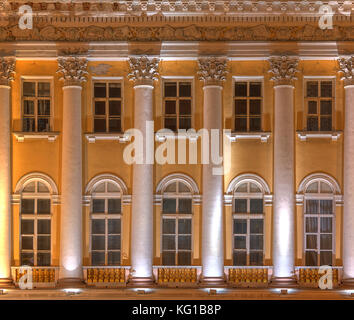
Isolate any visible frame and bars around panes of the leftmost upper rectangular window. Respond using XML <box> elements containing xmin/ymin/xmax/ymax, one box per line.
<box><xmin>20</xmin><ymin>76</ymin><xmax>55</xmax><ymax>135</ymax></box>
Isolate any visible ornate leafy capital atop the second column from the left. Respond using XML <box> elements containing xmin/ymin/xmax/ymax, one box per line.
<box><xmin>57</xmin><ymin>55</ymin><xmax>88</xmax><ymax>87</ymax></box>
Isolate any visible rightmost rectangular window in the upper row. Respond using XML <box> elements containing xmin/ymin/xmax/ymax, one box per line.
<box><xmin>305</xmin><ymin>80</ymin><xmax>334</xmax><ymax>131</ymax></box>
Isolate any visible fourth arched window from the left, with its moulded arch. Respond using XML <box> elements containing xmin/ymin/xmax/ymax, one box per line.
<box><xmin>227</xmin><ymin>174</ymin><xmax>270</xmax><ymax>266</ymax></box>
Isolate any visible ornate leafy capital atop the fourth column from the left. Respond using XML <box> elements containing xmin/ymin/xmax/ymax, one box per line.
<box><xmin>198</xmin><ymin>57</ymin><xmax>227</xmax><ymax>86</ymax></box>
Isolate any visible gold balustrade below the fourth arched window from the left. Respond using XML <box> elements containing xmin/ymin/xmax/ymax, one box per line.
<box><xmin>225</xmin><ymin>266</ymin><xmax>272</xmax><ymax>288</ymax></box>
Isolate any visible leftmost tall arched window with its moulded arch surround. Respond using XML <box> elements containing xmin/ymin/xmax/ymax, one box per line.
<box><xmin>15</xmin><ymin>173</ymin><xmax>58</xmax><ymax>266</ymax></box>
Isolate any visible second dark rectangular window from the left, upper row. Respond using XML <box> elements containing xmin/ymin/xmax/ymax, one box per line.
<box><xmin>93</xmin><ymin>82</ymin><xmax>122</xmax><ymax>133</ymax></box>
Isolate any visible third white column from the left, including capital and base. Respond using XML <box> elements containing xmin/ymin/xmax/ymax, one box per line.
<box><xmin>129</xmin><ymin>57</ymin><xmax>158</xmax><ymax>286</ymax></box>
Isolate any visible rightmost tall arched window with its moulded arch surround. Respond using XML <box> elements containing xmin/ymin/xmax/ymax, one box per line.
<box><xmin>299</xmin><ymin>174</ymin><xmax>340</xmax><ymax>266</ymax></box>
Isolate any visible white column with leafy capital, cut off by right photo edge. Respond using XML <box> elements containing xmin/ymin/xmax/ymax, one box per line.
<box><xmin>339</xmin><ymin>56</ymin><xmax>354</xmax><ymax>287</ymax></box>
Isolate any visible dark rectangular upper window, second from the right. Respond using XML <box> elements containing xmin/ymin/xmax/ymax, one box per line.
<box><xmin>234</xmin><ymin>81</ymin><xmax>262</xmax><ymax>132</ymax></box>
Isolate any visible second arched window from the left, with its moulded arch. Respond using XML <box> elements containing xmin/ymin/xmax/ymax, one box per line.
<box><xmin>86</xmin><ymin>175</ymin><xmax>127</xmax><ymax>266</ymax></box>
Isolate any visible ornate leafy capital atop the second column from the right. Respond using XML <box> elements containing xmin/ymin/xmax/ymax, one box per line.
<box><xmin>268</xmin><ymin>55</ymin><xmax>299</xmax><ymax>86</ymax></box>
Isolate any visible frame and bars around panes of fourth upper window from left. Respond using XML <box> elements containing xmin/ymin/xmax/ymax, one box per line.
<box><xmin>232</xmin><ymin>76</ymin><xmax>265</xmax><ymax>133</ymax></box>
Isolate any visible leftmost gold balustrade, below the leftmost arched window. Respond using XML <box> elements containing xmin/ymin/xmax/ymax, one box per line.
<box><xmin>11</xmin><ymin>267</ymin><xmax>59</xmax><ymax>288</ymax></box>
